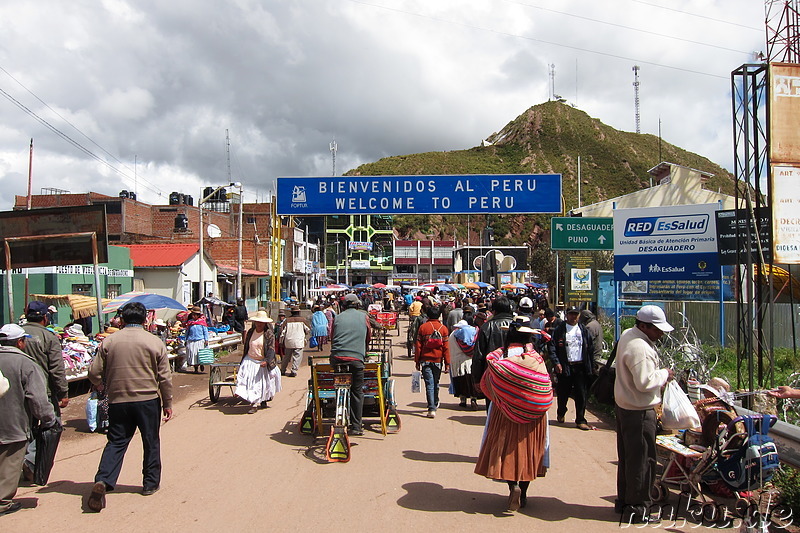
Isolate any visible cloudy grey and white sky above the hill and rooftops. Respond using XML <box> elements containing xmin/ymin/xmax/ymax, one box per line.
<box><xmin>0</xmin><ymin>0</ymin><xmax>765</xmax><ymax>210</ymax></box>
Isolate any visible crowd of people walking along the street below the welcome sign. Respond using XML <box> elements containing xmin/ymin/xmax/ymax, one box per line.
<box><xmin>0</xmin><ymin>291</ymin><xmax>800</xmax><ymax>523</ymax></box>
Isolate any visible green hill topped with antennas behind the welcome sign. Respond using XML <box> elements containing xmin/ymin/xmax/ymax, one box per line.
<box><xmin>346</xmin><ymin>102</ymin><xmax>734</xmax><ymax>246</ymax></box>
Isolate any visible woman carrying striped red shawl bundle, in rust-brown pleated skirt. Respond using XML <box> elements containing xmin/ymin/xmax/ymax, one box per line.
<box><xmin>475</xmin><ymin>316</ymin><xmax>553</xmax><ymax>511</ymax></box>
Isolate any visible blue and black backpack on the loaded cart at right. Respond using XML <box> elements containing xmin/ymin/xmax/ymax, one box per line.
<box><xmin>717</xmin><ymin>415</ymin><xmax>780</xmax><ymax>491</ymax></box>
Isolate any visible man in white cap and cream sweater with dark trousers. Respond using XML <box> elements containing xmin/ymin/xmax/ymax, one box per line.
<box><xmin>614</xmin><ymin>305</ymin><xmax>674</xmax><ymax>523</ymax></box>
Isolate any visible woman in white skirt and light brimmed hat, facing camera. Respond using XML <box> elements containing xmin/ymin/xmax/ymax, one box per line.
<box><xmin>234</xmin><ymin>311</ymin><xmax>281</xmax><ymax>414</ymax></box>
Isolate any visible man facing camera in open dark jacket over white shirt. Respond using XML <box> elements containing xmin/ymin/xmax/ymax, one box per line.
<box><xmin>550</xmin><ymin>307</ymin><xmax>594</xmax><ymax>431</ymax></box>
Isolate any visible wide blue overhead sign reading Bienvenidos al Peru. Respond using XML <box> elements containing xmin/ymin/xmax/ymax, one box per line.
<box><xmin>277</xmin><ymin>174</ymin><xmax>561</xmax><ymax>215</ymax></box>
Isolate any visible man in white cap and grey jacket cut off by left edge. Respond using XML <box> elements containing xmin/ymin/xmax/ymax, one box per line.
<box><xmin>0</xmin><ymin>324</ymin><xmax>57</xmax><ymax>515</ymax></box>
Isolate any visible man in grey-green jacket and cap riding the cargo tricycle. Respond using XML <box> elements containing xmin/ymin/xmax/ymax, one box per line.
<box><xmin>330</xmin><ymin>294</ymin><xmax>372</xmax><ymax>436</ymax></box>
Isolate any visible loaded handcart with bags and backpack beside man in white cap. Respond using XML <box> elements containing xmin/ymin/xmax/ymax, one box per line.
<box><xmin>651</xmin><ymin>415</ymin><xmax>777</xmax><ymax>516</ymax></box>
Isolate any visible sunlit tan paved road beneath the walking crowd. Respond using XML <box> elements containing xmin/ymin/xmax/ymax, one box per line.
<box><xmin>0</xmin><ymin>318</ymin><xmax>708</xmax><ymax>533</ymax></box>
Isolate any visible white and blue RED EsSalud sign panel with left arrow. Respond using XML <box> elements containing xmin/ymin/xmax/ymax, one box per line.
<box><xmin>614</xmin><ymin>204</ymin><xmax>720</xmax><ymax>281</ymax></box>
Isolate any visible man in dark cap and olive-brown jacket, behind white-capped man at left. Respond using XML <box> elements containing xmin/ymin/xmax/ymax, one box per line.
<box><xmin>22</xmin><ymin>300</ymin><xmax>69</xmax><ymax>481</ymax></box>
